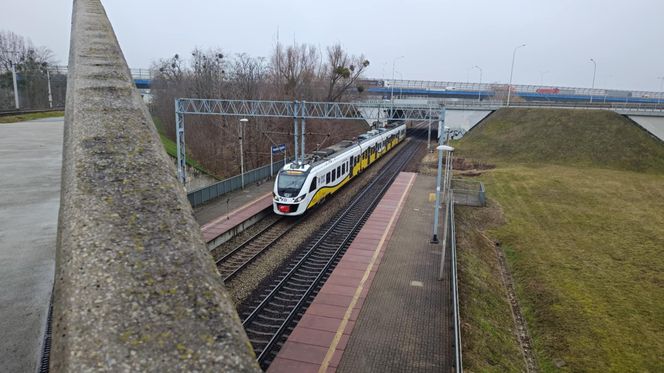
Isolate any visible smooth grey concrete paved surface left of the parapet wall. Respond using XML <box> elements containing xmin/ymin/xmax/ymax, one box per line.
<box><xmin>0</xmin><ymin>118</ymin><xmax>63</xmax><ymax>372</ymax></box>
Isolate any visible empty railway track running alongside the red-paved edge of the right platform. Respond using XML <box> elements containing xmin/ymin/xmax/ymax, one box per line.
<box><xmin>243</xmin><ymin>132</ymin><xmax>426</xmax><ymax>368</ymax></box>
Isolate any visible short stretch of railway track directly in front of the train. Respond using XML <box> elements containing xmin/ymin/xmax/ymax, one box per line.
<box><xmin>217</xmin><ymin>217</ymin><xmax>299</xmax><ymax>282</ymax></box>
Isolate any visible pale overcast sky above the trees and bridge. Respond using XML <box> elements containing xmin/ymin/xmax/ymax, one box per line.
<box><xmin>5</xmin><ymin>0</ymin><xmax>664</xmax><ymax>90</ymax></box>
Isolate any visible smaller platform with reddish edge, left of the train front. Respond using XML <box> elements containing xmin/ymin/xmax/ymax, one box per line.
<box><xmin>194</xmin><ymin>180</ymin><xmax>273</xmax><ymax>249</ymax></box>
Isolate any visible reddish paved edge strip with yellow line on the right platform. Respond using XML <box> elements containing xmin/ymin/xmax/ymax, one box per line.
<box><xmin>268</xmin><ymin>172</ymin><xmax>415</xmax><ymax>373</ymax></box>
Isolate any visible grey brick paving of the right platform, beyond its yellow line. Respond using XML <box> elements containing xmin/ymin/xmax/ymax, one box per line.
<box><xmin>336</xmin><ymin>175</ymin><xmax>452</xmax><ymax>373</ymax></box>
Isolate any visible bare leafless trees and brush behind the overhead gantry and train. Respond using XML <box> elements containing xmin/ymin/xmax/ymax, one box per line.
<box><xmin>152</xmin><ymin>44</ymin><xmax>369</xmax><ymax>177</ymax></box>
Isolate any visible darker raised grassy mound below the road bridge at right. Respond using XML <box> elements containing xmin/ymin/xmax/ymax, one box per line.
<box><xmin>459</xmin><ymin>109</ymin><xmax>664</xmax><ymax>172</ymax></box>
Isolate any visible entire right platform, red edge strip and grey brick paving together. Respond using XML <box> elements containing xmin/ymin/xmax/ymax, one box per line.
<box><xmin>268</xmin><ymin>172</ymin><xmax>451</xmax><ymax>373</ymax></box>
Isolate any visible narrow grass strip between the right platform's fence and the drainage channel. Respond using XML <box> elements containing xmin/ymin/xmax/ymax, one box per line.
<box><xmin>455</xmin><ymin>203</ymin><xmax>525</xmax><ymax>372</ymax></box>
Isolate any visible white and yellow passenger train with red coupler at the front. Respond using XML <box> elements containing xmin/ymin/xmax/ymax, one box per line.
<box><xmin>272</xmin><ymin>124</ymin><xmax>406</xmax><ymax>216</ymax></box>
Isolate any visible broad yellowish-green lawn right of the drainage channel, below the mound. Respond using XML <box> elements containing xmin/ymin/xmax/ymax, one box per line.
<box><xmin>484</xmin><ymin>166</ymin><xmax>664</xmax><ymax>372</ymax></box>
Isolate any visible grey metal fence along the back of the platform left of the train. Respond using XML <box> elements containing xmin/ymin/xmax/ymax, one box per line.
<box><xmin>187</xmin><ymin>160</ymin><xmax>288</xmax><ymax>207</ymax></box>
